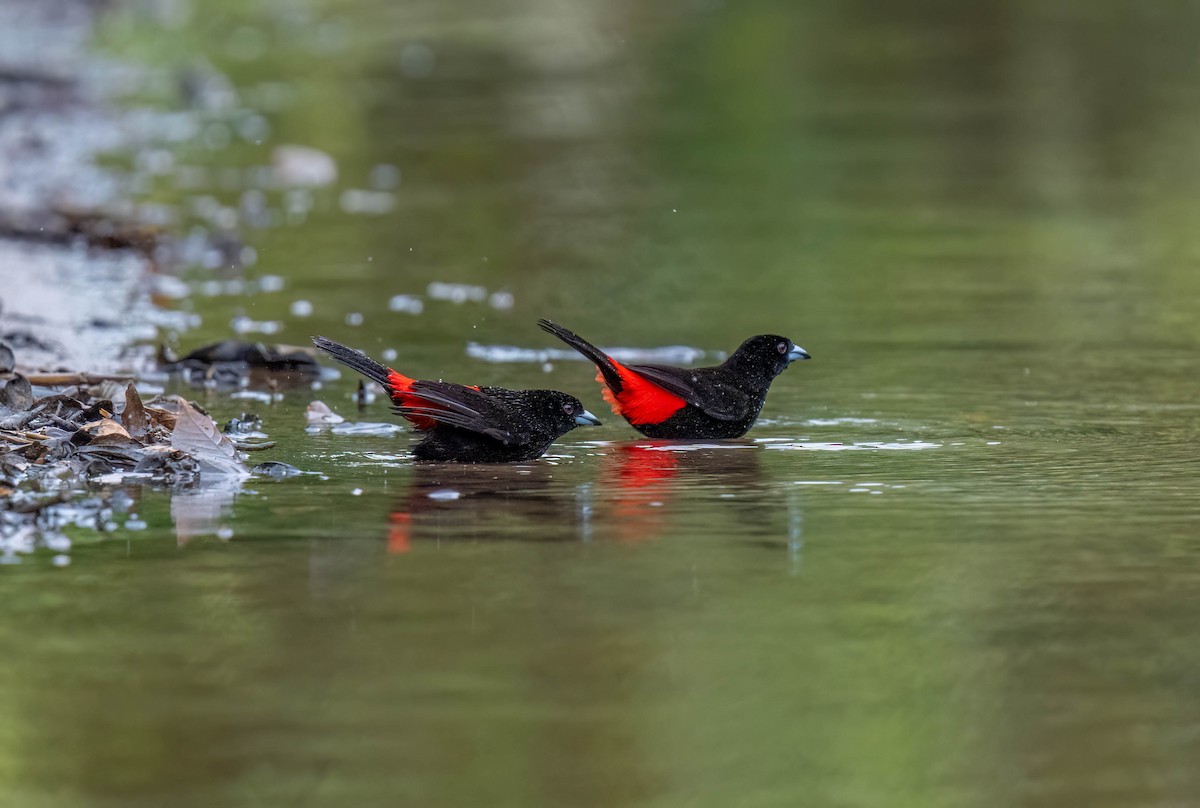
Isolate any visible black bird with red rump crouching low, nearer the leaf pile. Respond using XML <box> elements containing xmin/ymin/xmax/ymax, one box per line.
<box><xmin>312</xmin><ymin>336</ymin><xmax>600</xmax><ymax>463</ymax></box>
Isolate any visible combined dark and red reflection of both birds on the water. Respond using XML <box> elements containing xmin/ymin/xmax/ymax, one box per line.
<box><xmin>388</xmin><ymin>438</ymin><xmax>778</xmax><ymax>552</ymax></box>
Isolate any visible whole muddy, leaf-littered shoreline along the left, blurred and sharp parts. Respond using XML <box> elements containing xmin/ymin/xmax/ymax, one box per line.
<box><xmin>0</xmin><ymin>0</ymin><xmax>263</xmax><ymax>564</ymax></box>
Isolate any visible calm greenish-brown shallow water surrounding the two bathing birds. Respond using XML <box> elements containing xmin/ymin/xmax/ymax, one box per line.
<box><xmin>0</xmin><ymin>0</ymin><xmax>1200</xmax><ymax>807</ymax></box>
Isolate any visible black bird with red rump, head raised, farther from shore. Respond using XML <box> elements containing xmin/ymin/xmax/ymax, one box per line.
<box><xmin>538</xmin><ymin>319</ymin><xmax>809</xmax><ymax>439</ymax></box>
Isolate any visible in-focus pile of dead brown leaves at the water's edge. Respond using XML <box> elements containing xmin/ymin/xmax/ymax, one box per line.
<box><xmin>0</xmin><ymin>343</ymin><xmax>265</xmax><ymax>563</ymax></box>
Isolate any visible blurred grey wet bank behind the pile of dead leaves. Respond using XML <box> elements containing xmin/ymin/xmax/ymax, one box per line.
<box><xmin>0</xmin><ymin>0</ymin><xmax>199</xmax><ymax>373</ymax></box>
